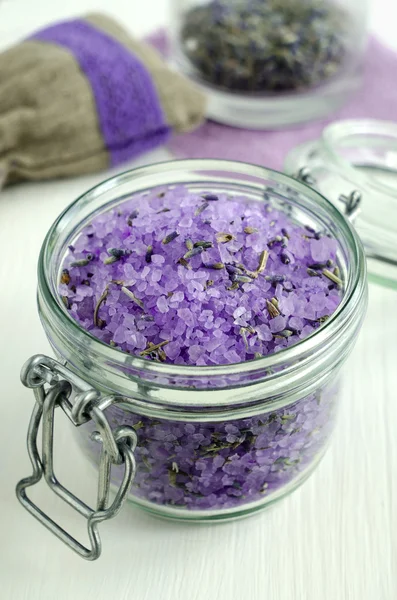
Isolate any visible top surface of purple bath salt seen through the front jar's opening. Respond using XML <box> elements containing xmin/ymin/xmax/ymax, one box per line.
<box><xmin>59</xmin><ymin>186</ymin><xmax>342</xmax><ymax>366</ymax></box>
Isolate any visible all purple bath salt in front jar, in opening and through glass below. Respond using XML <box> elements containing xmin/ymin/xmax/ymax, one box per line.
<box><xmin>63</xmin><ymin>186</ymin><xmax>343</xmax><ymax>511</ymax></box>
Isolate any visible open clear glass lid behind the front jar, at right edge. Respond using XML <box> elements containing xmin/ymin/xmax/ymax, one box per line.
<box><xmin>285</xmin><ymin>120</ymin><xmax>397</xmax><ymax>289</ymax></box>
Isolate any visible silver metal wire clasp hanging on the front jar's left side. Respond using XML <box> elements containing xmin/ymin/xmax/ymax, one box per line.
<box><xmin>16</xmin><ymin>355</ymin><xmax>137</xmax><ymax>560</ymax></box>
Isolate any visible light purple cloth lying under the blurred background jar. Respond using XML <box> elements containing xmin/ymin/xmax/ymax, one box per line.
<box><xmin>148</xmin><ymin>32</ymin><xmax>397</xmax><ymax>170</ymax></box>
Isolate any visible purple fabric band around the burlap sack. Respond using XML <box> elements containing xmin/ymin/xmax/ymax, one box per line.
<box><xmin>31</xmin><ymin>19</ymin><xmax>170</xmax><ymax>166</ymax></box>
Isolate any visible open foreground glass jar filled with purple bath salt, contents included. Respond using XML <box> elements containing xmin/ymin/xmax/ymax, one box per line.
<box><xmin>17</xmin><ymin>160</ymin><xmax>367</xmax><ymax>556</ymax></box>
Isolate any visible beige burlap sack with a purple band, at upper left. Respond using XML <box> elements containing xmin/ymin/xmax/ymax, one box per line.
<box><xmin>0</xmin><ymin>14</ymin><xmax>205</xmax><ymax>183</ymax></box>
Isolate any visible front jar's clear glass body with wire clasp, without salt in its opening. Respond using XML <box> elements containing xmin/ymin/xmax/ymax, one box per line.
<box><xmin>18</xmin><ymin>160</ymin><xmax>367</xmax><ymax>558</ymax></box>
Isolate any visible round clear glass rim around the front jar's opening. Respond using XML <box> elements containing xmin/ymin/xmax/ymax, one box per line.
<box><xmin>38</xmin><ymin>159</ymin><xmax>366</xmax><ymax>406</ymax></box>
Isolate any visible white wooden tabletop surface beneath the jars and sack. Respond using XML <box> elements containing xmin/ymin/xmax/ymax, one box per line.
<box><xmin>0</xmin><ymin>0</ymin><xmax>397</xmax><ymax>600</ymax></box>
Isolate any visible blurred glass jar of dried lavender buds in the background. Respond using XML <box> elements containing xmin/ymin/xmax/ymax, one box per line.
<box><xmin>170</xmin><ymin>0</ymin><xmax>368</xmax><ymax>129</ymax></box>
